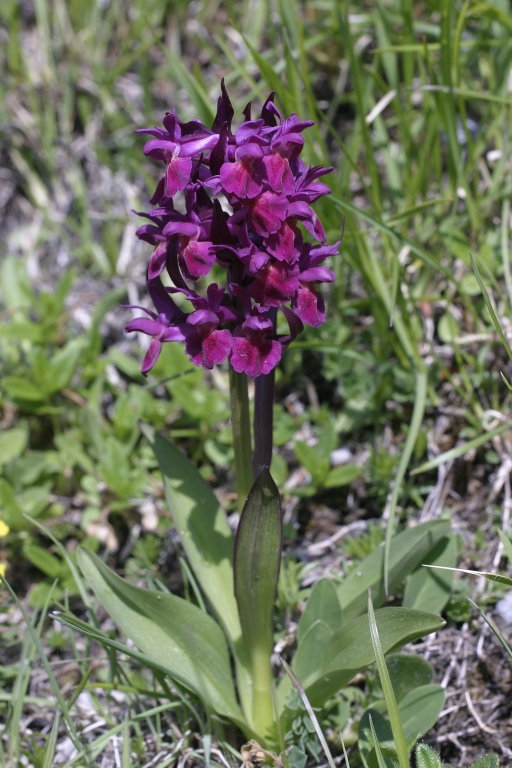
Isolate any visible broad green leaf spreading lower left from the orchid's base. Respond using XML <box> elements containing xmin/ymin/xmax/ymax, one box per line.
<box><xmin>78</xmin><ymin>549</ymin><xmax>244</xmax><ymax>727</ymax></box>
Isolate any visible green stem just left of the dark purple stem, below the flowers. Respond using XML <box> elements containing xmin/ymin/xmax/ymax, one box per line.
<box><xmin>229</xmin><ymin>367</ymin><xmax>254</xmax><ymax>512</ymax></box>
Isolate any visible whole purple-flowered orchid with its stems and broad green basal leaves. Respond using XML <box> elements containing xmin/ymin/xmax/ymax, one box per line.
<box><xmin>63</xmin><ymin>84</ymin><xmax>449</xmax><ymax>748</ymax></box>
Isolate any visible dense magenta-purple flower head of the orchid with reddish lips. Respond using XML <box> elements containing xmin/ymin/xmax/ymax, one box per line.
<box><xmin>126</xmin><ymin>82</ymin><xmax>339</xmax><ymax>378</ymax></box>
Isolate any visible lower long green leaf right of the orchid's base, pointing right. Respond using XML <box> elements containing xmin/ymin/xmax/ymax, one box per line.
<box><xmin>278</xmin><ymin>608</ymin><xmax>446</xmax><ymax>711</ymax></box>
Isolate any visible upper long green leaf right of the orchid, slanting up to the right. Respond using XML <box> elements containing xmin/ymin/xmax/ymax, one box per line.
<box><xmin>338</xmin><ymin>520</ymin><xmax>450</xmax><ymax>622</ymax></box>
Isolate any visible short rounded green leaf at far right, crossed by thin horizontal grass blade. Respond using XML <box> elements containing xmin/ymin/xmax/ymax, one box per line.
<box><xmin>402</xmin><ymin>533</ymin><xmax>457</xmax><ymax>613</ymax></box>
